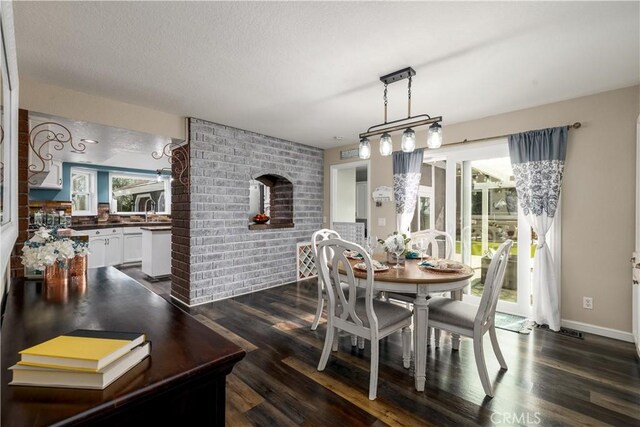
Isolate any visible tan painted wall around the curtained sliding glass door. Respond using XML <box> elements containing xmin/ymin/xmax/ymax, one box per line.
<box><xmin>324</xmin><ymin>86</ymin><xmax>640</xmax><ymax>332</ymax></box>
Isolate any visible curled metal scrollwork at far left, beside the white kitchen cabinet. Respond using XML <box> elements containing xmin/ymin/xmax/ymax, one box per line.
<box><xmin>29</xmin><ymin>122</ymin><xmax>98</xmax><ymax>184</ymax></box>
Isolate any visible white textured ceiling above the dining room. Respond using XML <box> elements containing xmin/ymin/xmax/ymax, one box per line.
<box><xmin>14</xmin><ymin>2</ymin><xmax>640</xmax><ymax>148</ymax></box>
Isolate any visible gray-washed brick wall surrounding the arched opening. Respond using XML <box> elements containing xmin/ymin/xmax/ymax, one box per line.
<box><xmin>172</xmin><ymin>119</ymin><xmax>323</xmax><ymax>305</ymax></box>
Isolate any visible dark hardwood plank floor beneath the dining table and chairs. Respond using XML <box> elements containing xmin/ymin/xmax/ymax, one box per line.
<box><xmin>117</xmin><ymin>268</ymin><xmax>640</xmax><ymax>426</ymax></box>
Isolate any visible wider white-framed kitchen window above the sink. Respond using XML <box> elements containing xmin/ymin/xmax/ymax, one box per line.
<box><xmin>109</xmin><ymin>173</ymin><xmax>171</xmax><ymax>214</ymax></box>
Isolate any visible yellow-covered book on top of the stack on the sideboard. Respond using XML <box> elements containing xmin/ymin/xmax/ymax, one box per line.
<box><xmin>18</xmin><ymin>329</ymin><xmax>146</xmax><ymax>372</ymax></box>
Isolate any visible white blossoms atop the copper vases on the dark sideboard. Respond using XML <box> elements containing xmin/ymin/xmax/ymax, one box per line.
<box><xmin>22</xmin><ymin>227</ymin><xmax>89</xmax><ymax>270</ymax></box>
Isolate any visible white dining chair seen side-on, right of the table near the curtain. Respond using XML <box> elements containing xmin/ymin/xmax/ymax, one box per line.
<box><xmin>429</xmin><ymin>240</ymin><xmax>513</xmax><ymax>397</ymax></box>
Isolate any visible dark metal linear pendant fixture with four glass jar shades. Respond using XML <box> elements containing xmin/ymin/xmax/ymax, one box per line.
<box><xmin>358</xmin><ymin>67</ymin><xmax>442</xmax><ymax>159</ymax></box>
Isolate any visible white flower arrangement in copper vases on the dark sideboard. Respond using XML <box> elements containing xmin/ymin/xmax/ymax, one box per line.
<box><xmin>22</xmin><ymin>227</ymin><xmax>89</xmax><ymax>285</ymax></box>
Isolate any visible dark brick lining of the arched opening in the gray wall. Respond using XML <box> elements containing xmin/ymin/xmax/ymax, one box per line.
<box><xmin>249</xmin><ymin>173</ymin><xmax>294</xmax><ymax>230</ymax></box>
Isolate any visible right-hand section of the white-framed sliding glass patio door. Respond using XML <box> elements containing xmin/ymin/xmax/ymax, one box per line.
<box><xmin>436</xmin><ymin>139</ymin><xmax>535</xmax><ymax>316</ymax></box>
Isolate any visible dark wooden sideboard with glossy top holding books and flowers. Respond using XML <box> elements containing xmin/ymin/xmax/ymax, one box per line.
<box><xmin>0</xmin><ymin>267</ymin><xmax>245</xmax><ymax>426</ymax></box>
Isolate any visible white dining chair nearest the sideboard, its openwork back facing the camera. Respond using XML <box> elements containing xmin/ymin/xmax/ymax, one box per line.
<box><xmin>318</xmin><ymin>239</ymin><xmax>413</xmax><ymax>400</ymax></box>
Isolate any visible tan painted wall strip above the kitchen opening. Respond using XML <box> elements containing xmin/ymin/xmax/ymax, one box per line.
<box><xmin>20</xmin><ymin>78</ymin><xmax>186</xmax><ymax>139</ymax></box>
